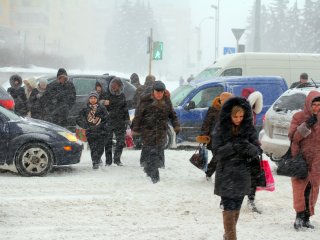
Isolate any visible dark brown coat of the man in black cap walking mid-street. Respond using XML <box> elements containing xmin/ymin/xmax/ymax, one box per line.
<box><xmin>132</xmin><ymin>94</ymin><xmax>179</xmax><ymax>146</ymax></box>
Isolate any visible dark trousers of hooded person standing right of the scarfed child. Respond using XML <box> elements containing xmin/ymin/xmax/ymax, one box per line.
<box><xmin>105</xmin><ymin>126</ymin><xmax>126</xmax><ymax>165</ymax></box>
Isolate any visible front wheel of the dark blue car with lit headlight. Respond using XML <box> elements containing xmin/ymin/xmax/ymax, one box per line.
<box><xmin>15</xmin><ymin>143</ymin><xmax>53</xmax><ymax>177</ymax></box>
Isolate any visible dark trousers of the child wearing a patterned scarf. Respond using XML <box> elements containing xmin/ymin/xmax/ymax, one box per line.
<box><xmin>87</xmin><ymin>134</ymin><xmax>105</xmax><ymax>165</ymax></box>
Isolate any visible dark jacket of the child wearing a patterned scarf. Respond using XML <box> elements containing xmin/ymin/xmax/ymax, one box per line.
<box><xmin>76</xmin><ymin>104</ymin><xmax>109</xmax><ymax>137</ymax></box>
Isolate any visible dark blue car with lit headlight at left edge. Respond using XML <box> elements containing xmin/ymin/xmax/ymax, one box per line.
<box><xmin>0</xmin><ymin>107</ymin><xmax>83</xmax><ymax>176</ymax></box>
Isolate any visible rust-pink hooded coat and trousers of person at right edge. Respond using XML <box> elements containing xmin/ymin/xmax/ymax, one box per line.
<box><xmin>288</xmin><ymin>91</ymin><xmax>320</xmax><ymax>216</ymax></box>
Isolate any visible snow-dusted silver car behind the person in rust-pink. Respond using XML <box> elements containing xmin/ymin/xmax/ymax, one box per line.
<box><xmin>259</xmin><ymin>83</ymin><xmax>320</xmax><ymax>161</ymax></box>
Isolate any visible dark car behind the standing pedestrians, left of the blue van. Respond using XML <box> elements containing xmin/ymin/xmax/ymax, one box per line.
<box><xmin>38</xmin><ymin>74</ymin><xmax>136</xmax><ymax>130</ymax></box>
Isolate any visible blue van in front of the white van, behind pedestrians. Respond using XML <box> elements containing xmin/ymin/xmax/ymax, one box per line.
<box><xmin>168</xmin><ymin>76</ymin><xmax>288</xmax><ymax>148</ymax></box>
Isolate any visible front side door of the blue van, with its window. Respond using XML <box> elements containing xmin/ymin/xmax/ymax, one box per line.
<box><xmin>178</xmin><ymin>85</ymin><xmax>224</xmax><ymax>141</ymax></box>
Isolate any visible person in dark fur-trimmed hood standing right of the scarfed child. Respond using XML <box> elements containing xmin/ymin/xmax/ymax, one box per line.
<box><xmin>102</xmin><ymin>77</ymin><xmax>130</xmax><ymax>166</ymax></box>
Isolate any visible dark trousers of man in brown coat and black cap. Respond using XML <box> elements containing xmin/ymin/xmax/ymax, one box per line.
<box><xmin>141</xmin><ymin>145</ymin><xmax>164</xmax><ymax>180</ymax></box>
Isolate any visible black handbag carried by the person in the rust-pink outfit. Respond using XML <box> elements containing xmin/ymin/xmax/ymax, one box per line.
<box><xmin>277</xmin><ymin>144</ymin><xmax>308</xmax><ymax>179</ymax></box>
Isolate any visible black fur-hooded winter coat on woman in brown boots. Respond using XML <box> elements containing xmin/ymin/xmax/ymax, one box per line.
<box><xmin>212</xmin><ymin>97</ymin><xmax>262</xmax><ymax>198</ymax></box>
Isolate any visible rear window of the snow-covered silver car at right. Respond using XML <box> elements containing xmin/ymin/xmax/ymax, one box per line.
<box><xmin>273</xmin><ymin>93</ymin><xmax>306</xmax><ymax>112</ymax></box>
